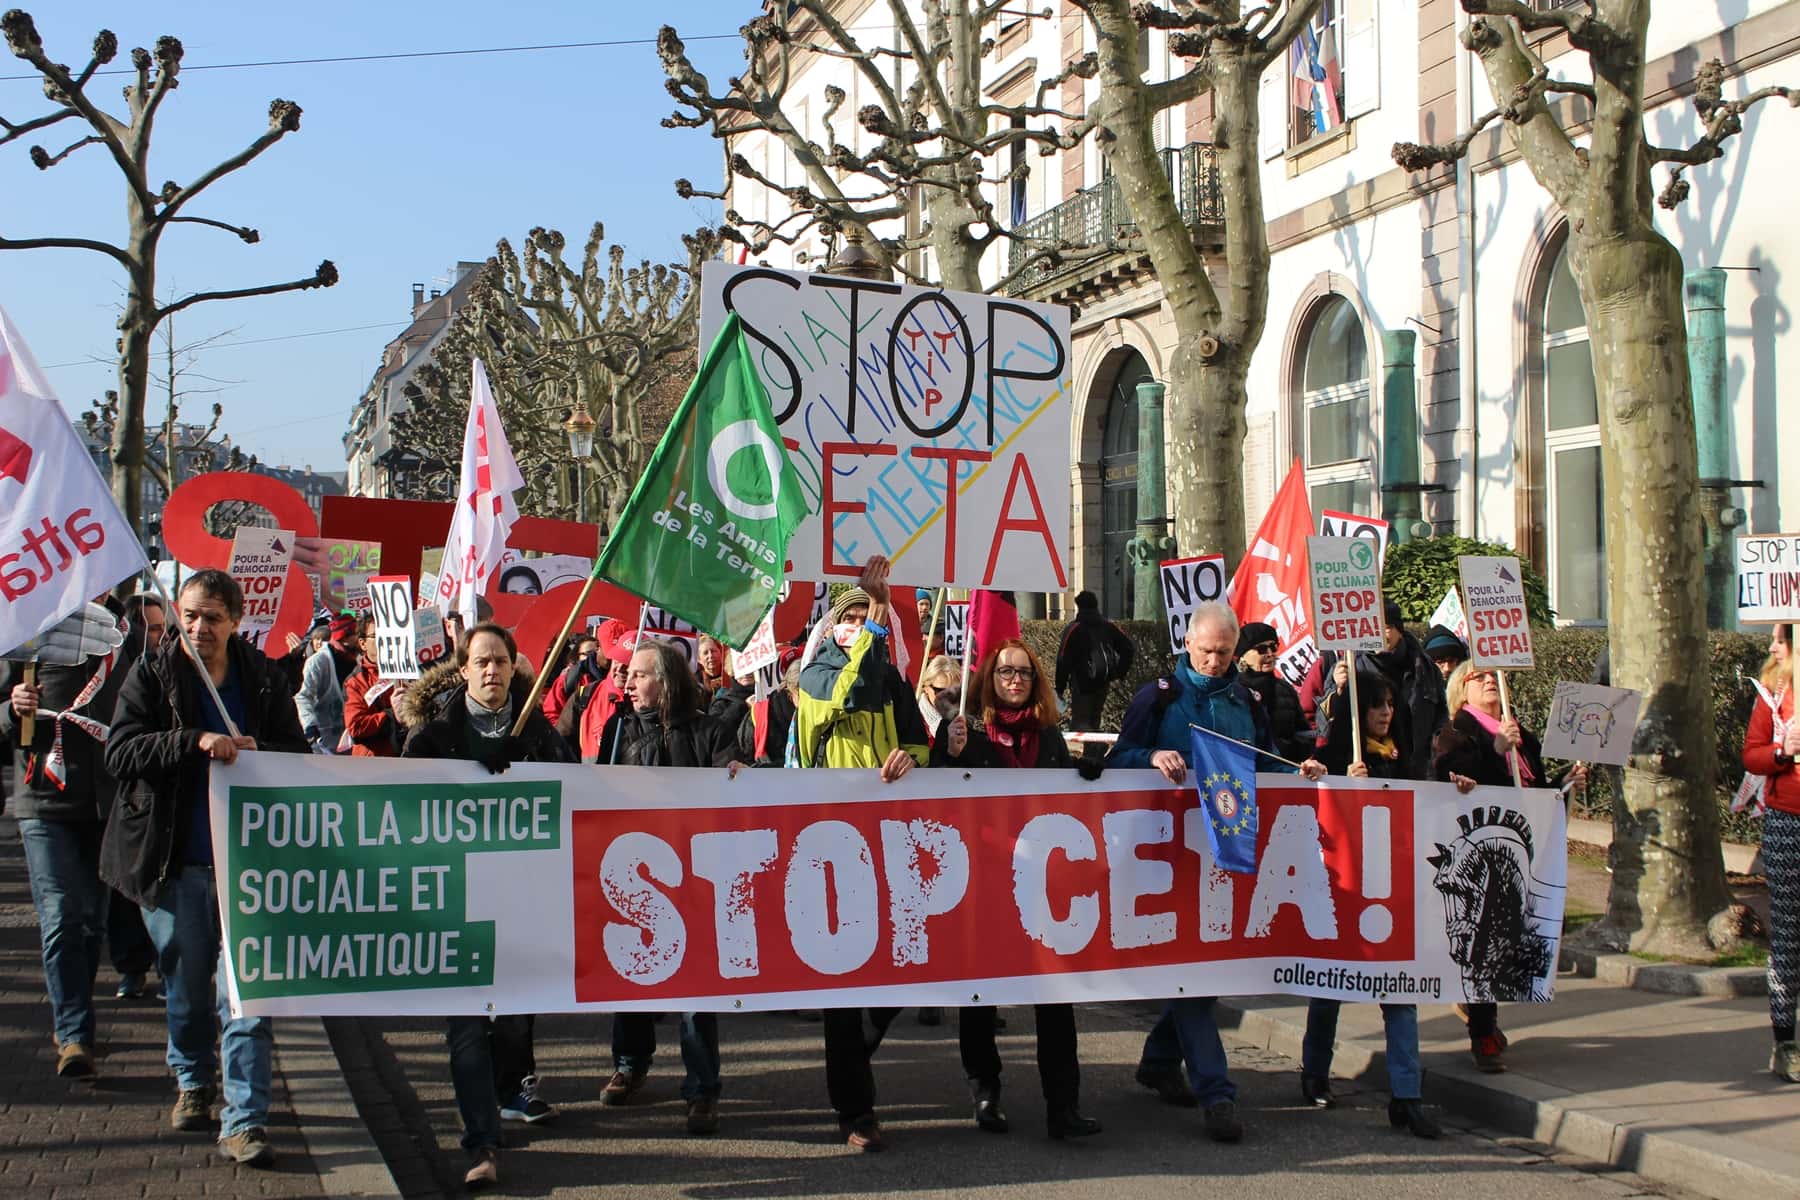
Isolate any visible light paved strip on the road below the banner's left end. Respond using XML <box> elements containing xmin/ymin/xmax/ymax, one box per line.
<box><xmin>275</xmin><ymin>1016</ymin><xmax>400</xmax><ymax>1200</ymax></box>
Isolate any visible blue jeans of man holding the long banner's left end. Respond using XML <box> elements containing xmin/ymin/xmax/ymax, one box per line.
<box><xmin>144</xmin><ymin>865</ymin><xmax>275</xmax><ymax>1137</ymax></box>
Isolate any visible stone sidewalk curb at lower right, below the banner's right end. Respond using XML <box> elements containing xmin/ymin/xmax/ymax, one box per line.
<box><xmin>1217</xmin><ymin>1000</ymin><xmax>1800</xmax><ymax>1200</ymax></box>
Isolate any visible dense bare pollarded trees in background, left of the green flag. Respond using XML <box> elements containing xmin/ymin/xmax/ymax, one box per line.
<box><xmin>396</xmin><ymin>221</ymin><xmax>718</xmax><ymax>524</ymax></box>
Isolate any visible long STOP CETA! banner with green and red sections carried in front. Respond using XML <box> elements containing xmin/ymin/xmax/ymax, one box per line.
<box><xmin>211</xmin><ymin>754</ymin><xmax>1566</xmax><ymax>1016</ymax></box>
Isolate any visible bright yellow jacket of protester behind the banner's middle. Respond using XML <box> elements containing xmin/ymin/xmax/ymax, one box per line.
<box><xmin>795</xmin><ymin>628</ymin><xmax>931</xmax><ymax>768</ymax></box>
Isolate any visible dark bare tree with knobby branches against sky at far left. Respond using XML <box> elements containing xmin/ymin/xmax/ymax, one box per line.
<box><xmin>0</xmin><ymin>9</ymin><xmax>338</xmax><ymax>539</ymax></box>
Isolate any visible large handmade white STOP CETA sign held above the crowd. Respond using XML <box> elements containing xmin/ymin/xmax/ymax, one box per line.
<box><xmin>700</xmin><ymin>263</ymin><xmax>1071</xmax><ymax>592</ymax></box>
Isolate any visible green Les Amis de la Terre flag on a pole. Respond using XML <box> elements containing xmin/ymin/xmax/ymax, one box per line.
<box><xmin>594</xmin><ymin>313</ymin><xmax>806</xmax><ymax>649</ymax></box>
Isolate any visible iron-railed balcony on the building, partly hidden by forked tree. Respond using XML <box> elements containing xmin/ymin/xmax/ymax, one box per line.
<box><xmin>1006</xmin><ymin>142</ymin><xmax>1226</xmax><ymax>297</ymax></box>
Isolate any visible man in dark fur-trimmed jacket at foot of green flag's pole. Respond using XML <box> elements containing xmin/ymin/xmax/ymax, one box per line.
<box><xmin>401</xmin><ymin>621</ymin><xmax>574</xmax><ymax>1189</ymax></box>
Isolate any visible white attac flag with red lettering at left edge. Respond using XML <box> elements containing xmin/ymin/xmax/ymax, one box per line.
<box><xmin>0</xmin><ymin>309</ymin><xmax>149</xmax><ymax>648</ymax></box>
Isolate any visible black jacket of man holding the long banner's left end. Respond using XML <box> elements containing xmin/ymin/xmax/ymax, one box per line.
<box><xmin>101</xmin><ymin>637</ymin><xmax>308</xmax><ymax>907</ymax></box>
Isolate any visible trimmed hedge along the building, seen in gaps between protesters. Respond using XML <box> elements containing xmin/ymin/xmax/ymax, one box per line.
<box><xmin>1024</xmin><ymin>621</ymin><xmax>1769</xmax><ymax>842</ymax></box>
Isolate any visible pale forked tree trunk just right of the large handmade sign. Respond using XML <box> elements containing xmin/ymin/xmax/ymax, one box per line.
<box><xmin>1075</xmin><ymin>0</ymin><xmax>1319</xmax><ymax>561</ymax></box>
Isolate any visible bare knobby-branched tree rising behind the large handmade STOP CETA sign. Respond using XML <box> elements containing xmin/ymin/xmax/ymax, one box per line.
<box><xmin>657</xmin><ymin>0</ymin><xmax>1118</xmax><ymax>291</ymax></box>
